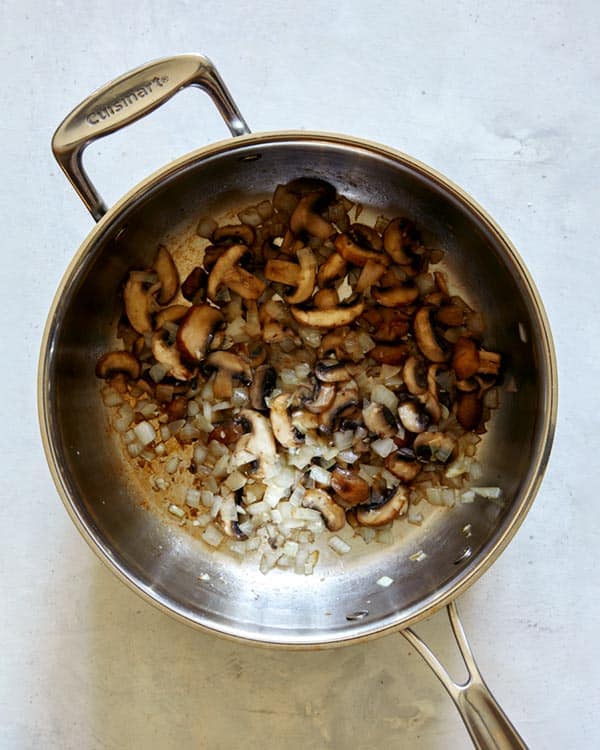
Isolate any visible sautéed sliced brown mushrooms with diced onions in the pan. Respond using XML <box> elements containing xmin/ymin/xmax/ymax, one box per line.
<box><xmin>96</xmin><ymin>178</ymin><xmax>501</xmax><ymax>574</ymax></box>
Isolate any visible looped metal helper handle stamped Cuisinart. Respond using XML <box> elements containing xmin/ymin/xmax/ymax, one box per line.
<box><xmin>52</xmin><ymin>55</ymin><xmax>250</xmax><ymax>221</ymax></box>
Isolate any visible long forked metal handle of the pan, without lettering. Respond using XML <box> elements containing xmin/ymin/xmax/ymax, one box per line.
<box><xmin>401</xmin><ymin>602</ymin><xmax>527</xmax><ymax>750</ymax></box>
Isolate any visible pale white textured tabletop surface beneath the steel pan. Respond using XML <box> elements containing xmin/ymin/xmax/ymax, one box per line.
<box><xmin>0</xmin><ymin>0</ymin><xmax>600</xmax><ymax>750</ymax></box>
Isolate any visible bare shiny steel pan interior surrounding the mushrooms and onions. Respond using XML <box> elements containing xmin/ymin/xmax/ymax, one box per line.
<box><xmin>41</xmin><ymin>134</ymin><xmax>554</xmax><ymax>645</ymax></box>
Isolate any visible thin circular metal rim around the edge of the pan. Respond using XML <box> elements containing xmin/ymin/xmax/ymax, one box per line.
<box><xmin>37</xmin><ymin>130</ymin><xmax>558</xmax><ymax>650</ymax></box>
